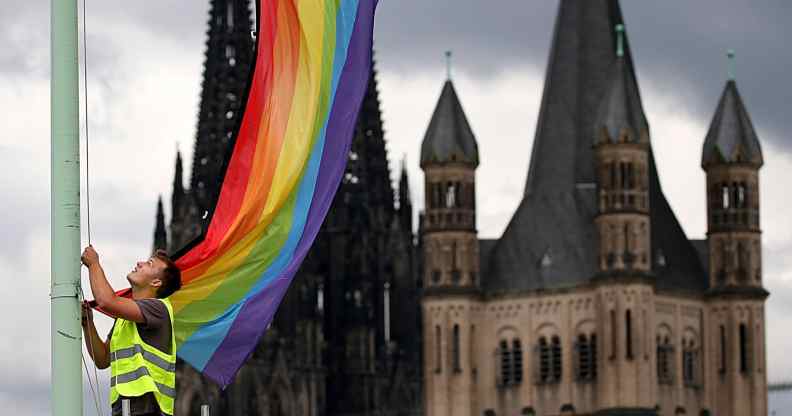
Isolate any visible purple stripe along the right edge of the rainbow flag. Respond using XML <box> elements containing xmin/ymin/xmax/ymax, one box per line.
<box><xmin>203</xmin><ymin>0</ymin><xmax>377</xmax><ymax>388</ymax></box>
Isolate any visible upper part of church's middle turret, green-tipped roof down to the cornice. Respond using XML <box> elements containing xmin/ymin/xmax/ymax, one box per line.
<box><xmin>594</xmin><ymin>24</ymin><xmax>651</xmax><ymax>273</ymax></box>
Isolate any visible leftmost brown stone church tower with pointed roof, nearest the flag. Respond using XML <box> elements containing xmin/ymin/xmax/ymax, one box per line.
<box><xmin>421</xmin><ymin>60</ymin><xmax>479</xmax><ymax>416</ymax></box>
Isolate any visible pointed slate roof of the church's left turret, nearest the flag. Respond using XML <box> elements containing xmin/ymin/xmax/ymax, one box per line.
<box><xmin>421</xmin><ymin>80</ymin><xmax>479</xmax><ymax>166</ymax></box>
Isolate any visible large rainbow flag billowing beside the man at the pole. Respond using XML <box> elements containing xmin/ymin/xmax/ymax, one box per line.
<box><xmin>171</xmin><ymin>0</ymin><xmax>377</xmax><ymax>388</ymax></box>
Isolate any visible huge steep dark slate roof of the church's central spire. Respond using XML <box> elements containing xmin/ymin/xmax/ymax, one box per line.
<box><xmin>482</xmin><ymin>0</ymin><xmax>706</xmax><ymax>292</ymax></box>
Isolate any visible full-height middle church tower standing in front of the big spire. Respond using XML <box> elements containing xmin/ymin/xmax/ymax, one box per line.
<box><xmin>593</xmin><ymin>23</ymin><xmax>656</xmax><ymax>409</ymax></box>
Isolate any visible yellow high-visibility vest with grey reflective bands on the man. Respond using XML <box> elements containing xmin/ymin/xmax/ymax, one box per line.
<box><xmin>110</xmin><ymin>299</ymin><xmax>176</xmax><ymax>415</ymax></box>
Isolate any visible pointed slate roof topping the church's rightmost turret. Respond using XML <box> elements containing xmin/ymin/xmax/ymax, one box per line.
<box><xmin>701</xmin><ymin>80</ymin><xmax>763</xmax><ymax>167</ymax></box>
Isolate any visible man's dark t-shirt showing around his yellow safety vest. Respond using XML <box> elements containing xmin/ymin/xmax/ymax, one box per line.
<box><xmin>107</xmin><ymin>299</ymin><xmax>172</xmax><ymax>416</ymax></box>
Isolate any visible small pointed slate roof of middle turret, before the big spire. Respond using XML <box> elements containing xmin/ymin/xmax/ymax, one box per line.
<box><xmin>591</xmin><ymin>58</ymin><xmax>649</xmax><ymax>142</ymax></box>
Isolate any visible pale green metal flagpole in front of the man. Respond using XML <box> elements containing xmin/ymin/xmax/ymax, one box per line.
<box><xmin>50</xmin><ymin>0</ymin><xmax>83</xmax><ymax>416</ymax></box>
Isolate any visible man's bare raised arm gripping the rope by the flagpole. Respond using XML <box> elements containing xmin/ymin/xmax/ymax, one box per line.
<box><xmin>82</xmin><ymin>246</ymin><xmax>146</xmax><ymax>323</ymax></box>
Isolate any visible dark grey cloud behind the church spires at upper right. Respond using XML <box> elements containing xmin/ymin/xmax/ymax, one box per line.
<box><xmin>376</xmin><ymin>0</ymin><xmax>792</xmax><ymax>152</ymax></box>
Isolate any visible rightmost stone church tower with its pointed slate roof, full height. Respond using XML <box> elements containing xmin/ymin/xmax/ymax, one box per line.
<box><xmin>701</xmin><ymin>51</ymin><xmax>768</xmax><ymax>416</ymax></box>
